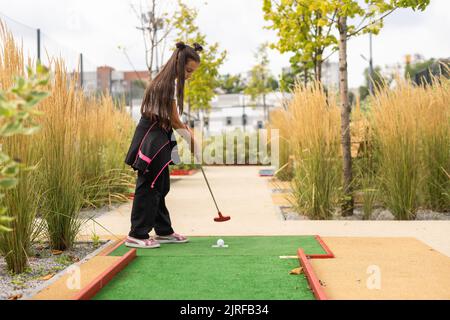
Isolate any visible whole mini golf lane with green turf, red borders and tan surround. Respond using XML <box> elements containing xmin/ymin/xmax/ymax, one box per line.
<box><xmin>32</xmin><ymin>236</ymin><xmax>450</xmax><ymax>300</ymax></box>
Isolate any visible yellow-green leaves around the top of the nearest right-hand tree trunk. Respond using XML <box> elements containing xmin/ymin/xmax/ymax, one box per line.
<box><xmin>263</xmin><ymin>0</ymin><xmax>429</xmax><ymax>81</ymax></box>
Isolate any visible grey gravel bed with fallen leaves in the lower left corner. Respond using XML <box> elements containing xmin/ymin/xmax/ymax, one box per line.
<box><xmin>0</xmin><ymin>242</ymin><xmax>105</xmax><ymax>300</ymax></box>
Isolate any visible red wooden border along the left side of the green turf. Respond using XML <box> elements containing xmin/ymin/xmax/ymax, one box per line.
<box><xmin>73</xmin><ymin>249</ymin><xmax>136</xmax><ymax>300</ymax></box>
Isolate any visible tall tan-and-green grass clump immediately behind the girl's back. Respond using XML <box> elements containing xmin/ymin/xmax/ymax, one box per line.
<box><xmin>79</xmin><ymin>95</ymin><xmax>135</xmax><ymax>208</ymax></box>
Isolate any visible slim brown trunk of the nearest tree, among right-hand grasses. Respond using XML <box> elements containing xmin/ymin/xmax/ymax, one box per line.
<box><xmin>338</xmin><ymin>16</ymin><xmax>353</xmax><ymax>216</ymax></box>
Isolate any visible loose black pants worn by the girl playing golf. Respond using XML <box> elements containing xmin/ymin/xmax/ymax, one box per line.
<box><xmin>128</xmin><ymin>167</ymin><xmax>174</xmax><ymax>239</ymax></box>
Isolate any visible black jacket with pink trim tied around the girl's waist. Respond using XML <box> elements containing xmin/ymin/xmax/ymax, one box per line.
<box><xmin>125</xmin><ymin>117</ymin><xmax>180</xmax><ymax>176</ymax></box>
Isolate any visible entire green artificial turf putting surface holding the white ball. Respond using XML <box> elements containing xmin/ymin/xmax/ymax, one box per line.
<box><xmin>85</xmin><ymin>236</ymin><xmax>332</xmax><ymax>300</ymax></box>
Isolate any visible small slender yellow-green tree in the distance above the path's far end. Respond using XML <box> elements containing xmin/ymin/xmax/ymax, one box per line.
<box><xmin>244</xmin><ymin>43</ymin><xmax>278</xmax><ymax>120</ymax></box>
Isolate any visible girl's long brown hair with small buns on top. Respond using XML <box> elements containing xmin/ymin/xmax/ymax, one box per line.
<box><xmin>141</xmin><ymin>42</ymin><xmax>203</xmax><ymax>131</ymax></box>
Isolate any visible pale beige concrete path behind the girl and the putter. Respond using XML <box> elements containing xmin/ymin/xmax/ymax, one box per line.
<box><xmin>81</xmin><ymin>166</ymin><xmax>450</xmax><ymax>256</ymax></box>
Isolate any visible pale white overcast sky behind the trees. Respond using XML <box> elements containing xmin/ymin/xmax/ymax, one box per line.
<box><xmin>0</xmin><ymin>0</ymin><xmax>450</xmax><ymax>87</ymax></box>
